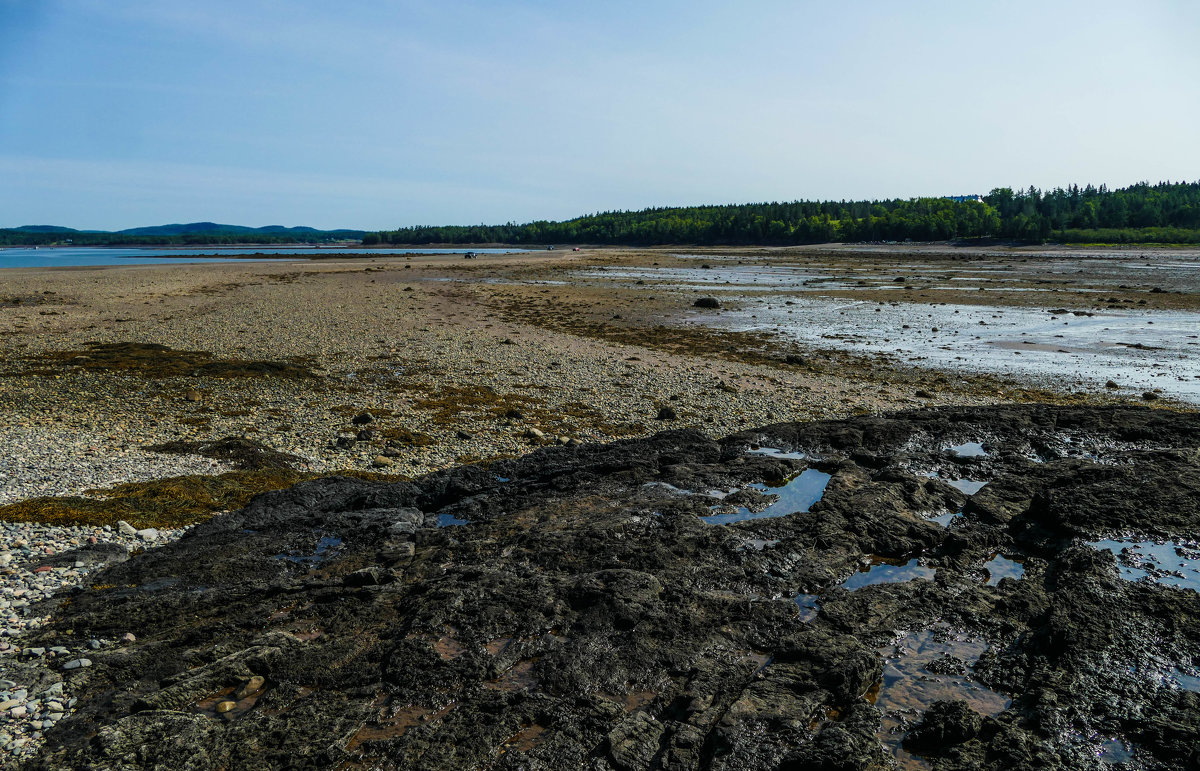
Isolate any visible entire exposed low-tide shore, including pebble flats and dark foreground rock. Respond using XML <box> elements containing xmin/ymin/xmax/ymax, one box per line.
<box><xmin>0</xmin><ymin>245</ymin><xmax>1200</xmax><ymax>769</ymax></box>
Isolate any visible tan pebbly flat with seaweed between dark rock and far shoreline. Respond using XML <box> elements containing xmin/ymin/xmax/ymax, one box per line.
<box><xmin>0</xmin><ymin>246</ymin><xmax>1200</xmax><ymax>501</ymax></box>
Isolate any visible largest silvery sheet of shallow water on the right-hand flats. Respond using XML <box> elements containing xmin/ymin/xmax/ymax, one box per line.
<box><xmin>724</xmin><ymin>295</ymin><xmax>1200</xmax><ymax>401</ymax></box>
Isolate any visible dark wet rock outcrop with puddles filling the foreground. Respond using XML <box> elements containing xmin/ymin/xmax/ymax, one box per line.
<box><xmin>18</xmin><ymin>405</ymin><xmax>1200</xmax><ymax>771</ymax></box>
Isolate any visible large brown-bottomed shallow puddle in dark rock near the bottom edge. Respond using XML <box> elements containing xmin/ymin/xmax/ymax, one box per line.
<box><xmin>866</xmin><ymin>626</ymin><xmax>1012</xmax><ymax>769</ymax></box>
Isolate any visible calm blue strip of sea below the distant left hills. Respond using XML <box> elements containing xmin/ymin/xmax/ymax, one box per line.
<box><xmin>0</xmin><ymin>246</ymin><xmax>521</xmax><ymax>268</ymax></box>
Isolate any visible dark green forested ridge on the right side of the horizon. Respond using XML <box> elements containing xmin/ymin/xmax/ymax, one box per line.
<box><xmin>364</xmin><ymin>183</ymin><xmax>1200</xmax><ymax>245</ymax></box>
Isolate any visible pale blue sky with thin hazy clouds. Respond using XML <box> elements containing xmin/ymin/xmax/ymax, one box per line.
<box><xmin>0</xmin><ymin>0</ymin><xmax>1200</xmax><ymax>229</ymax></box>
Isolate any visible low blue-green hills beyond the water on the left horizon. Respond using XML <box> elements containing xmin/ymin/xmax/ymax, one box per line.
<box><xmin>0</xmin><ymin>222</ymin><xmax>365</xmax><ymax>246</ymax></box>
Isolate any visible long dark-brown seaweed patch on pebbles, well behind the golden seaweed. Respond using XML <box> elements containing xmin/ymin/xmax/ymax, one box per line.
<box><xmin>31</xmin><ymin>342</ymin><xmax>316</xmax><ymax>378</ymax></box>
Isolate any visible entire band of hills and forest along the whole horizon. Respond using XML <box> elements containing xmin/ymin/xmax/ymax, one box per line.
<box><xmin>9</xmin><ymin>181</ymin><xmax>1200</xmax><ymax>246</ymax></box>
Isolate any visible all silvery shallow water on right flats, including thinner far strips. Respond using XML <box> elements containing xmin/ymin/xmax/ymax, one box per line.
<box><xmin>580</xmin><ymin>256</ymin><xmax>1200</xmax><ymax>401</ymax></box>
